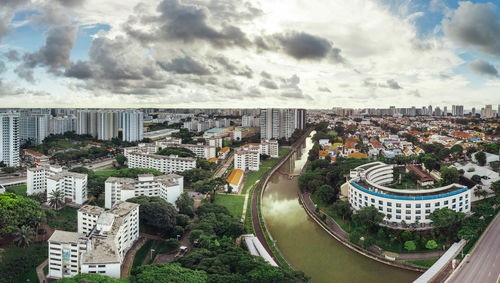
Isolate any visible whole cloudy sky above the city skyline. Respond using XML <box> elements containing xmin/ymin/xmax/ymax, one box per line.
<box><xmin>0</xmin><ymin>0</ymin><xmax>500</xmax><ymax>109</ymax></box>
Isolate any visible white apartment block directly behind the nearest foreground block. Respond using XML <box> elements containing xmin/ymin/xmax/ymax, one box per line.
<box><xmin>105</xmin><ymin>174</ymin><xmax>184</xmax><ymax>208</ymax></box>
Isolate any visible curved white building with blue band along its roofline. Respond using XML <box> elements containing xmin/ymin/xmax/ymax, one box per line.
<box><xmin>348</xmin><ymin>162</ymin><xmax>471</xmax><ymax>227</ymax></box>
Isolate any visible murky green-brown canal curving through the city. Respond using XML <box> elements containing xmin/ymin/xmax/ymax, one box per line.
<box><xmin>262</xmin><ymin>132</ymin><xmax>420</xmax><ymax>283</ymax></box>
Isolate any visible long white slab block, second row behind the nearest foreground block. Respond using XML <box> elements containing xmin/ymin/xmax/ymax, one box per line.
<box><xmin>124</xmin><ymin>146</ymin><xmax>196</xmax><ymax>174</ymax></box>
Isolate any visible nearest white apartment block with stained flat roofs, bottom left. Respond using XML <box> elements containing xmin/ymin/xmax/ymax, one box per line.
<box><xmin>48</xmin><ymin>202</ymin><xmax>139</xmax><ymax>279</ymax></box>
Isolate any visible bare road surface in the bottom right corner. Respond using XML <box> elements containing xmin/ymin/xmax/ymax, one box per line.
<box><xmin>451</xmin><ymin>214</ymin><xmax>500</xmax><ymax>283</ymax></box>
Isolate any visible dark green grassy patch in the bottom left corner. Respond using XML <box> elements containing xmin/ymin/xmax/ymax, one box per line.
<box><xmin>0</xmin><ymin>241</ymin><xmax>48</xmax><ymax>282</ymax></box>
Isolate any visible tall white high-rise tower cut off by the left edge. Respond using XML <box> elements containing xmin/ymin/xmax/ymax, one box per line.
<box><xmin>0</xmin><ymin>112</ymin><xmax>20</xmax><ymax>166</ymax></box>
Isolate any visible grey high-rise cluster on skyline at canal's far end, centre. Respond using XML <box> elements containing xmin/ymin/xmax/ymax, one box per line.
<box><xmin>260</xmin><ymin>108</ymin><xmax>306</xmax><ymax>140</ymax></box>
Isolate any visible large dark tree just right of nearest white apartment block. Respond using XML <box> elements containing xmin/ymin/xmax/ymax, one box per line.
<box><xmin>127</xmin><ymin>196</ymin><xmax>178</xmax><ymax>235</ymax></box>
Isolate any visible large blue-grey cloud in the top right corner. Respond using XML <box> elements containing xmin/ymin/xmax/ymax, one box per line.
<box><xmin>442</xmin><ymin>2</ymin><xmax>500</xmax><ymax>56</ymax></box>
